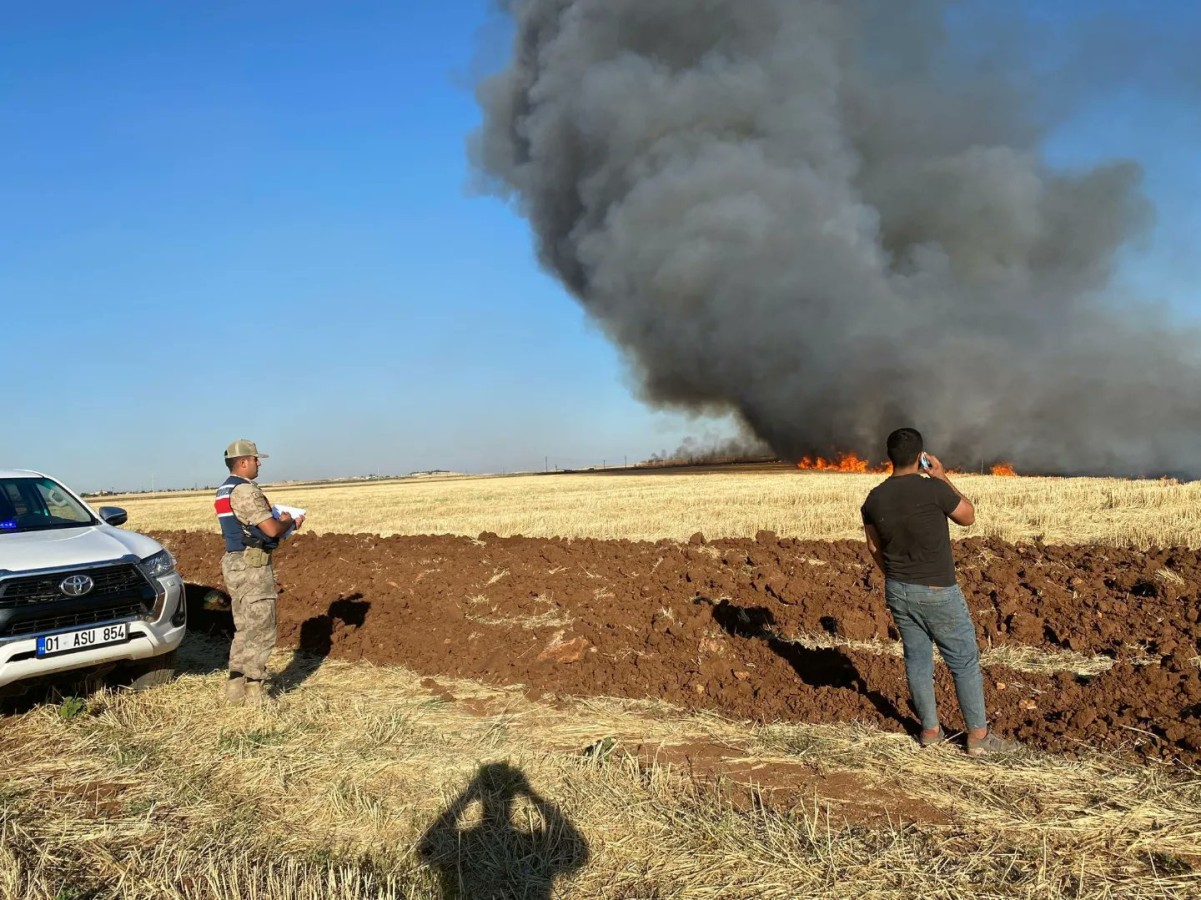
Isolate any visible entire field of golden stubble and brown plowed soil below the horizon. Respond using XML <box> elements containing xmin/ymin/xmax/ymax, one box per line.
<box><xmin>9</xmin><ymin>466</ymin><xmax>1201</xmax><ymax>898</ymax></box>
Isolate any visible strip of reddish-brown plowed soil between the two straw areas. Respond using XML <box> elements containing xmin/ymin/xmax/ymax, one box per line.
<box><xmin>159</xmin><ymin>532</ymin><xmax>1201</xmax><ymax>764</ymax></box>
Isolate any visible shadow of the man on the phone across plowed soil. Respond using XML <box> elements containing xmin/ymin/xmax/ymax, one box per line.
<box><xmin>697</xmin><ymin>597</ymin><xmax>918</xmax><ymax>733</ymax></box>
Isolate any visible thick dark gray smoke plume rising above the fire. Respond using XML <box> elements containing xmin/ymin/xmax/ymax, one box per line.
<box><xmin>472</xmin><ymin>0</ymin><xmax>1201</xmax><ymax>473</ymax></box>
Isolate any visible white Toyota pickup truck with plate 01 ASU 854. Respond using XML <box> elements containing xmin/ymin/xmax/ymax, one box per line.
<box><xmin>0</xmin><ymin>470</ymin><xmax>187</xmax><ymax>693</ymax></box>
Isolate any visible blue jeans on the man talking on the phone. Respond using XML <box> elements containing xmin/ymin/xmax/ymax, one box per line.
<box><xmin>884</xmin><ymin>580</ymin><xmax>988</xmax><ymax>731</ymax></box>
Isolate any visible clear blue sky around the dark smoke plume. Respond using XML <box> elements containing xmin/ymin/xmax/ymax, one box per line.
<box><xmin>0</xmin><ymin>0</ymin><xmax>1201</xmax><ymax>490</ymax></box>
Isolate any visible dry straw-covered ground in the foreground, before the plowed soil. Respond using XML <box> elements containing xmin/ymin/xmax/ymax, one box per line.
<box><xmin>0</xmin><ymin>638</ymin><xmax>1201</xmax><ymax>900</ymax></box>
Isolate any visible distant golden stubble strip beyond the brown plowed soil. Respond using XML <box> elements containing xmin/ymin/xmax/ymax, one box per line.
<box><xmin>103</xmin><ymin>469</ymin><xmax>1201</xmax><ymax>548</ymax></box>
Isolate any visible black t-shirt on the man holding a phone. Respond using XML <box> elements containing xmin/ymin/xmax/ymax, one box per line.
<box><xmin>862</xmin><ymin>475</ymin><xmax>960</xmax><ymax>588</ymax></box>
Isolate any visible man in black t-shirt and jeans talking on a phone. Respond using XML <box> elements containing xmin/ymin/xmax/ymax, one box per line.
<box><xmin>862</xmin><ymin>428</ymin><xmax>1017</xmax><ymax>756</ymax></box>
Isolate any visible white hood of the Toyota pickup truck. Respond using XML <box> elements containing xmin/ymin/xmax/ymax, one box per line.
<box><xmin>0</xmin><ymin>525</ymin><xmax>162</xmax><ymax>572</ymax></box>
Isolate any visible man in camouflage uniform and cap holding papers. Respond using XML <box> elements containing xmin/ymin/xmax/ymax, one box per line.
<box><xmin>214</xmin><ymin>440</ymin><xmax>304</xmax><ymax>704</ymax></box>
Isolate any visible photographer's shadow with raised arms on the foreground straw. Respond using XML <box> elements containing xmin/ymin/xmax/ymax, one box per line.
<box><xmin>418</xmin><ymin>763</ymin><xmax>590</xmax><ymax>900</ymax></box>
